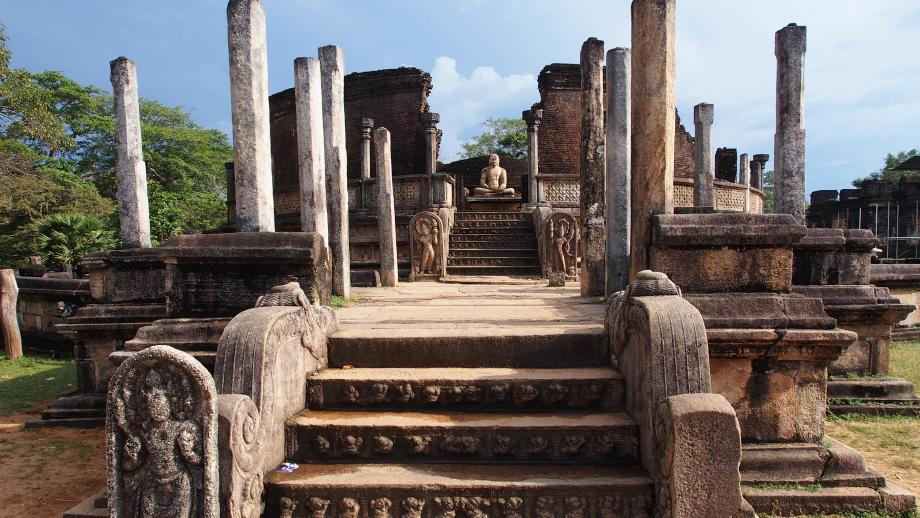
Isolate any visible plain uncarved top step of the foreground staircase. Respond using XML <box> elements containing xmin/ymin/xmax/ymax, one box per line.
<box><xmin>329</xmin><ymin>330</ymin><xmax>610</xmax><ymax>369</ymax></box>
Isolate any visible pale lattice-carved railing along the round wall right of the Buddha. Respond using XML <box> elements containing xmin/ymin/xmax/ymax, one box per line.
<box><xmin>537</xmin><ymin>174</ymin><xmax>764</xmax><ymax>214</ymax></box>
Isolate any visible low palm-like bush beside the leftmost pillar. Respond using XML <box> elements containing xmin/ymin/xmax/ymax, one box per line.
<box><xmin>35</xmin><ymin>213</ymin><xmax>116</xmax><ymax>267</ymax></box>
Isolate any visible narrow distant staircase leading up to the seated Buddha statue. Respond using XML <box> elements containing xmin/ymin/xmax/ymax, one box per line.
<box><xmin>447</xmin><ymin>211</ymin><xmax>542</xmax><ymax>277</ymax></box>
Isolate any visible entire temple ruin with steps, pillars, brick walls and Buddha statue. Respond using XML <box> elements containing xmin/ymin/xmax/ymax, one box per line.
<box><xmin>50</xmin><ymin>0</ymin><xmax>915</xmax><ymax>518</ymax></box>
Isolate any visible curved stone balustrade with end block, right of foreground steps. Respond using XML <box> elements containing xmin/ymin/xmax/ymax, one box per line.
<box><xmin>606</xmin><ymin>271</ymin><xmax>753</xmax><ymax>517</ymax></box>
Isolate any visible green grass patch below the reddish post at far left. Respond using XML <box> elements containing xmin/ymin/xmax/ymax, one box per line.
<box><xmin>0</xmin><ymin>356</ymin><xmax>77</xmax><ymax>416</ymax></box>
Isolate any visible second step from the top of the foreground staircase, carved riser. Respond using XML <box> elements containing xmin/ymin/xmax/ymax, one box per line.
<box><xmin>307</xmin><ymin>368</ymin><xmax>624</xmax><ymax>412</ymax></box>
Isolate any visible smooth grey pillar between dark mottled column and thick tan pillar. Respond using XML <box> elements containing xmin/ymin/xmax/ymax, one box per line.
<box><xmin>605</xmin><ymin>48</ymin><xmax>632</xmax><ymax>296</ymax></box>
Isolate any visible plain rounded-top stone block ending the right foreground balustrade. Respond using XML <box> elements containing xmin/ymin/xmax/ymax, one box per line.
<box><xmin>656</xmin><ymin>394</ymin><xmax>746</xmax><ymax>518</ymax></box>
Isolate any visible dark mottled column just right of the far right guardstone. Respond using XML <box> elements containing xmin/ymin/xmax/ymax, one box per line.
<box><xmin>580</xmin><ymin>38</ymin><xmax>607</xmax><ymax>296</ymax></box>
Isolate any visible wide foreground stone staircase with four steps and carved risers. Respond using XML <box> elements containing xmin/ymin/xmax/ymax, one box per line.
<box><xmin>265</xmin><ymin>316</ymin><xmax>653</xmax><ymax>518</ymax></box>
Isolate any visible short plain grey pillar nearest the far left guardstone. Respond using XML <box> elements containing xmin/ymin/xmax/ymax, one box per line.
<box><xmin>374</xmin><ymin>128</ymin><xmax>399</xmax><ymax>286</ymax></box>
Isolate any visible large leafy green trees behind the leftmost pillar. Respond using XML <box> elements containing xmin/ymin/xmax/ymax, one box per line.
<box><xmin>0</xmin><ymin>25</ymin><xmax>233</xmax><ymax>267</ymax></box>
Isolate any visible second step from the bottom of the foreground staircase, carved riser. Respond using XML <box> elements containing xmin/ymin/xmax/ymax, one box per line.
<box><xmin>285</xmin><ymin>411</ymin><xmax>638</xmax><ymax>465</ymax></box>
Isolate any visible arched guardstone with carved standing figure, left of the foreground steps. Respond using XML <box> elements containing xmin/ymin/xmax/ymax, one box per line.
<box><xmin>106</xmin><ymin>345</ymin><xmax>219</xmax><ymax>518</ymax></box>
